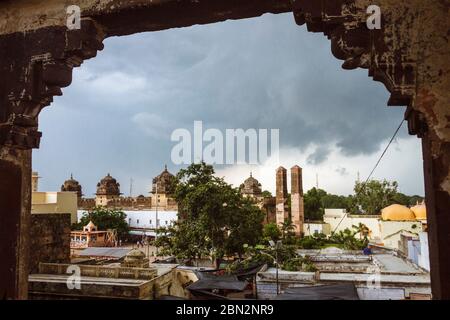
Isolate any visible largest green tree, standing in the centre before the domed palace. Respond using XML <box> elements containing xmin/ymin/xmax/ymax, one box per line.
<box><xmin>156</xmin><ymin>162</ymin><xmax>264</xmax><ymax>266</ymax></box>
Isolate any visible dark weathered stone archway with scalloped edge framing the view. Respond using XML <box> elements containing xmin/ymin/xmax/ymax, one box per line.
<box><xmin>0</xmin><ymin>0</ymin><xmax>450</xmax><ymax>299</ymax></box>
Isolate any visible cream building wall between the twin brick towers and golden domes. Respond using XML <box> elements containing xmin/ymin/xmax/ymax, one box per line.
<box><xmin>323</xmin><ymin>209</ymin><xmax>381</xmax><ymax>239</ymax></box>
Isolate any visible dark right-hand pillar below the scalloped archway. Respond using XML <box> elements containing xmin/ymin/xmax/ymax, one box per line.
<box><xmin>422</xmin><ymin>133</ymin><xmax>450</xmax><ymax>300</ymax></box>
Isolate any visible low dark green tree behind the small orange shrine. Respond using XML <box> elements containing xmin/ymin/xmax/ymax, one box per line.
<box><xmin>72</xmin><ymin>207</ymin><xmax>129</xmax><ymax>238</ymax></box>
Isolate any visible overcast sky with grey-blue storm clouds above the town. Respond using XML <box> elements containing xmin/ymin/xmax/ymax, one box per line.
<box><xmin>33</xmin><ymin>14</ymin><xmax>424</xmax><ymax>197</ymax></box>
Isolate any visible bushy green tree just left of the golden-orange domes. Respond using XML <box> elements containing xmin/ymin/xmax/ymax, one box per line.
<box><xmin>351</xmin><ymin>180</ymin><xmax>398</xmax><ymax>214</ymax></box>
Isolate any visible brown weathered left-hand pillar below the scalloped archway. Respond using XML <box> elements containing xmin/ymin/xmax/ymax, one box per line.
<box><xmin>0</xmin><ymin>147</ymin><xmax>31</xmax><ymax>299</ymax></box>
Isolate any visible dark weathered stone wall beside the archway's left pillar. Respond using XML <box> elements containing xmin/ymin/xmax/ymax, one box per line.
<box><xmin>30</xmin><ymin>214</ymin><xmax>70</xmax><ymax>273</ymax></box>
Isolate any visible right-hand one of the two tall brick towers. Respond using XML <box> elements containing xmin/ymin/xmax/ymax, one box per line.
<box><xmin>291</xmin><ymin>166</ymin><xmax>305</xmax><ymax>236</ymax></box>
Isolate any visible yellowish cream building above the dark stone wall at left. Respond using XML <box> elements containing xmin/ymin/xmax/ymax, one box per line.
<box><xmin>31</xmin><ymin>192</ymin><xmax>78</xmax><ymax>223</ymax></box>
